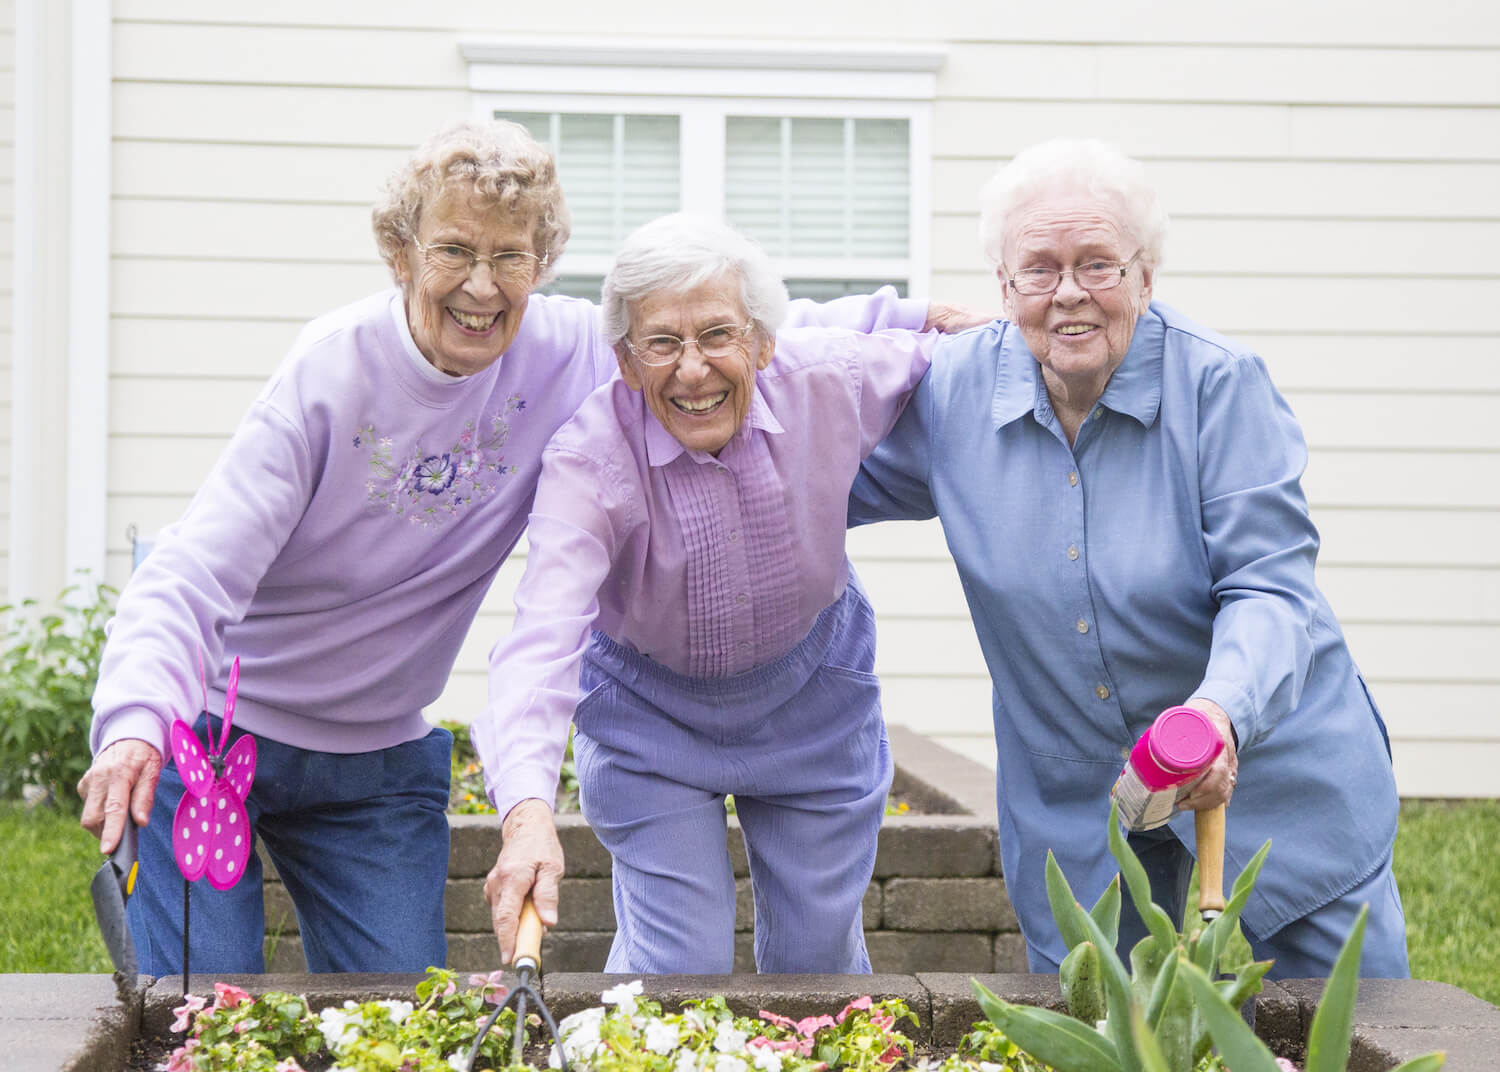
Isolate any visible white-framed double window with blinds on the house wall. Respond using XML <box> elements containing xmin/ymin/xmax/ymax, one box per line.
<box><xmin>464</xmin><ymin>39</ymin><xmax>941</xmax><ymax>298</ymax></box>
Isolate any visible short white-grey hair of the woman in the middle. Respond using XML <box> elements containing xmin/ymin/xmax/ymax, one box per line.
<box><xmin>603</xmin><ymin>213</ymin><xmax>788</xmax><ymax>346</ymax></box>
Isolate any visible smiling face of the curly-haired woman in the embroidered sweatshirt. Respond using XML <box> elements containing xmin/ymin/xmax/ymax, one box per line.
<box><xmin>396</xmin><ymin>186</ymin><xmax>540</xmax><ymax>376</ymax></box>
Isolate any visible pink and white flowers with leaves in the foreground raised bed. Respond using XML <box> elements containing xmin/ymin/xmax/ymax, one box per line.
<box><xmin>93</xmin><ymin>972</ymin><xmax>1476</xmax><ymax>1072</ymax></box>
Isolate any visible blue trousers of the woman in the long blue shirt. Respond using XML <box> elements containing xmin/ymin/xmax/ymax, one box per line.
<box><xmin>1116</xmin><ymin>826</ymin><xmax>1412</xmax><ymax>979</ymax></box>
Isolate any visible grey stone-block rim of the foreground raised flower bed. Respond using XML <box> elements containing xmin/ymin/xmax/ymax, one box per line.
<box><xmin>0</xmin><ymin>972</ymin><xmax>1500</xmax><ymax>1072</ymax></box>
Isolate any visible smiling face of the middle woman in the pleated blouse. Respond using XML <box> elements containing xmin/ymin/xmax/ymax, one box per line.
<box><xmin>618</xmin><ymin>279</ymin><xmax>773</xmax><ymax>454</ymax></box>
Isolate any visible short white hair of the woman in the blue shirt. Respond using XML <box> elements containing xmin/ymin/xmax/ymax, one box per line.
<box><xmin>980</xmin><ymin>138</ymin><xmax>1167</xmax><ymax>270</ymax></box>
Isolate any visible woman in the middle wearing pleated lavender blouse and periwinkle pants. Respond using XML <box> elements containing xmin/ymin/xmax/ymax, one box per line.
<box><xmin>473</xmin><ymin>216</ymin><xmax>929</xmax><ymax>973</ymax></box>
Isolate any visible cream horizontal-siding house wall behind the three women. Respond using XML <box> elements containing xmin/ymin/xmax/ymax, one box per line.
<box><xmin>99</xmin><ymin>0</ymin><xmax>1500</xmax><ymax>796</ymax></box>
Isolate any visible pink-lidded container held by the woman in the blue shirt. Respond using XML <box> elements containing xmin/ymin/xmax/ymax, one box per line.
<box><xmin>1110</xmin><ymin>706</ymin><xmax>1224</xmax><ymax>831</ymax></box>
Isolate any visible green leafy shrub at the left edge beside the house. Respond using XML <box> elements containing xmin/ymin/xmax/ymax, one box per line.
<box><xmin>0</xmin><ymin>583</ymin><xmax>117</xmax><ymax>808</ymax></box>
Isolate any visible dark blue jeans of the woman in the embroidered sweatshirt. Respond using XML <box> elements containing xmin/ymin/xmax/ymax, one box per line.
<box><xmin>126</xmin><ymin>715</ymin><xmax>453</xmax><ymax>976</ymax></box>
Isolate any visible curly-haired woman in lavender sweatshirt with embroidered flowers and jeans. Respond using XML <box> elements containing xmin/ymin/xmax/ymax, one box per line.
<box><xmin>80</xmin><ymin>123</ymin><xmax>951</xmax><ymax>975</ymax></box>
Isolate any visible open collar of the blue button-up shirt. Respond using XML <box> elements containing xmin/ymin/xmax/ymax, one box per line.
<box><xmin>992</xmin><ymin>306</ymin><xmax>1167</xmax><ymax>427</ymax></box>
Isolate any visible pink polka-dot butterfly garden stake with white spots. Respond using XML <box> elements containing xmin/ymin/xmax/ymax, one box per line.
<box><xmin>171</xmin><ymin>651</ymin><xmax>255</xmax><ymax>994</ymax></box>
